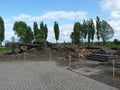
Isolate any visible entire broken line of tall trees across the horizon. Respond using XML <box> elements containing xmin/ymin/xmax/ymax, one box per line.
<box><xmin>0</xmin><ymin>16</ymin><xmax>114</xmax><ymax>44</ymax></box>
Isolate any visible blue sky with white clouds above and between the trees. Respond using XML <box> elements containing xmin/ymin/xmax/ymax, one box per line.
<box><xmin>0</xmin><ymin>0</ymin><xmax>120</xmax><ymax>42</ymax></box>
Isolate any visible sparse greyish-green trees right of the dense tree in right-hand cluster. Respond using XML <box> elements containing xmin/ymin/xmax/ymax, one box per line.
<box><xmin>82</xmin><ymin>16</ymin><xmax>114</xmax><ymax>43</ymax></box>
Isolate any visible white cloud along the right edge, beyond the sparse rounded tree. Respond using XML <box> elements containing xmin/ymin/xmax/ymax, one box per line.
<box><xmin>100</xmin><ymin>0</ymin><xmax>120</xmax><ymax>40</ymax></box>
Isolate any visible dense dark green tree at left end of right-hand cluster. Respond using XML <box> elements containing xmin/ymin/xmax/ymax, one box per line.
<box><xmin>70</xmin><ymin>22</ymin><xmax>83</xmax><ymax>44</ymax></box>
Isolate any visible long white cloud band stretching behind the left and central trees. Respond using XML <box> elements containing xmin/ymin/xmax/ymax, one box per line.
<box><xmin>5</xmin><ymin>11</ymin><xmax>87</xmax><ymax>42</ymax></box>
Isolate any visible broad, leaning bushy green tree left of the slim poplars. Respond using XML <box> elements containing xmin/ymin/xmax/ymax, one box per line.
<box><xmin>13</xmin><ymin>21</ymin><xmax>33</xmax><ymax>43</ymax></box>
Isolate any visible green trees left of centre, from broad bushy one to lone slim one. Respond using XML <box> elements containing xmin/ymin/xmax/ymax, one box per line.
<box><xmin>13</xmin><ymin>21</ymin><xmax>59</xmax><ymax>43</ymax></box>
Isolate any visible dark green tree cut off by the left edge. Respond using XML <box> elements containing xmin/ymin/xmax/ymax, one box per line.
<box><xmin>0</xmin><ymin>17</ymin><xmax>5</xmax><ymax>45</ymax></box>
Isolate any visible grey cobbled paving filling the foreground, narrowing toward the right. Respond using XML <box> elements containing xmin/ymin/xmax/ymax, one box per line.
<box><xmin>0</xmin><ymin>61</ymin><xmax>119</xmax><ymax>90</ymax></box>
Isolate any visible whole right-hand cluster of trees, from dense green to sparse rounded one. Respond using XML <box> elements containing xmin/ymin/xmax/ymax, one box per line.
<box><xmin>70</xmin><ymin>16</ymin><xmax>114</xmax><ymax>44</ymax></box>
